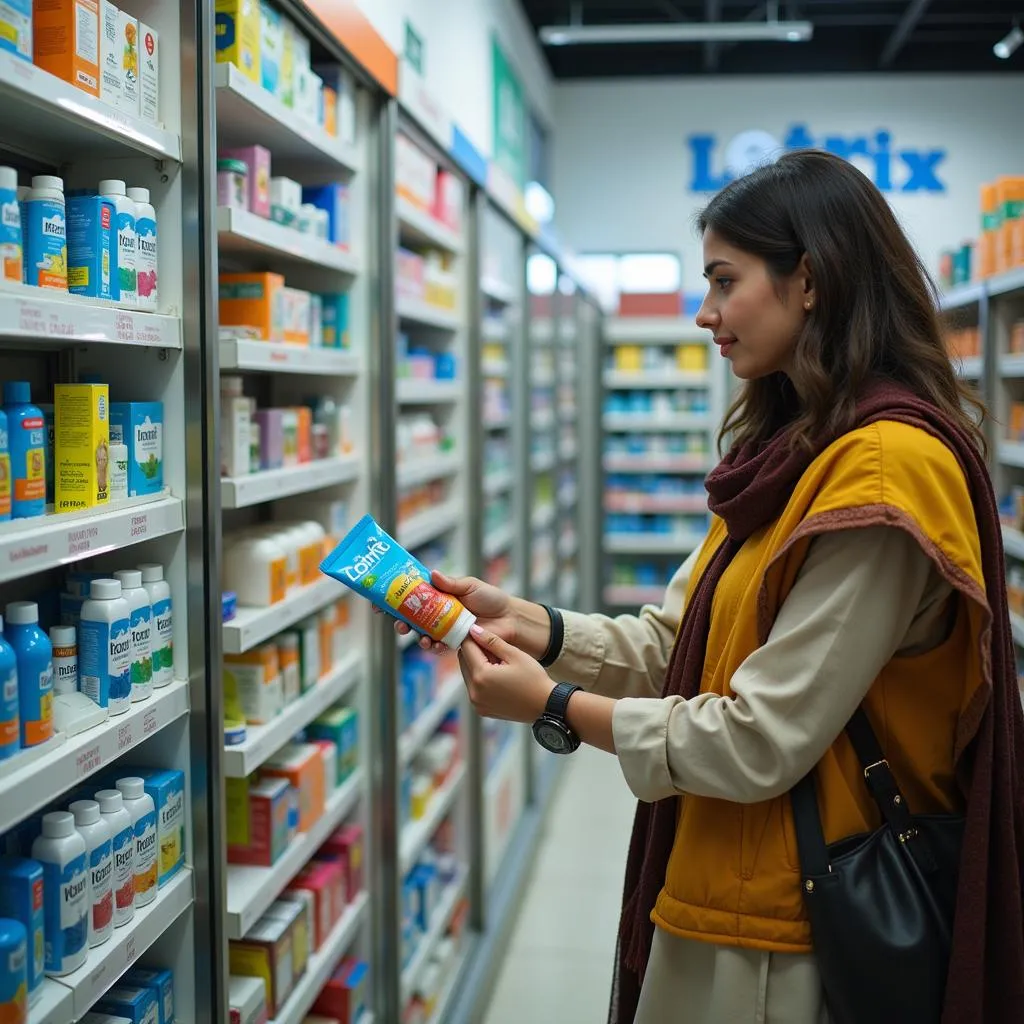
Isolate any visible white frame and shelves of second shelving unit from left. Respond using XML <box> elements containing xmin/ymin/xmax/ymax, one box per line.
<box><xmin>212</xmin><ymin>3</ymin><xmax>383</xmax><ymax>1024</ymax></box>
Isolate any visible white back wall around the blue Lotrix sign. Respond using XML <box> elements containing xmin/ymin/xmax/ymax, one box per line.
<box><xmin>553</xmin><ymin>76</ymin><xmax>1024</xmax><ymax>293</ymax></box>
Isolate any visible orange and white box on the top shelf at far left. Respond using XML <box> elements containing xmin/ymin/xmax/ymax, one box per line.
<box><xmin>32</xmin><ymin>0</ymin><xmax>99</xmax><ymax>96</ymax></box>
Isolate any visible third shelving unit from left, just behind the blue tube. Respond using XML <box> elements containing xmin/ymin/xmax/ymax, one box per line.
<box><xmin>387</xmin><ymin>119</ymin><xmax>479</xmax><ymax>1020</ymax></box>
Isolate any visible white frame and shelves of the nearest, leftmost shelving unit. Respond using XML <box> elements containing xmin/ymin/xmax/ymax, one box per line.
<box><xmin>0</xmin><ymin>0</ymin><xmax>221</xmax><ymax>1024</ymax></box>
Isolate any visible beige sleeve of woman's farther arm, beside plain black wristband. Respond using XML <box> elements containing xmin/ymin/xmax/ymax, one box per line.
<box><xmin>548</xmin><ymin>548</ymin><xmax>700</xmax><ymax>697</ymax></box>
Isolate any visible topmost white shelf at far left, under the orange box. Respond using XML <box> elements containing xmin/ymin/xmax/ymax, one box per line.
<box><xmin>0</xmin><ymin>50</ymin><xmax>181</xmax><ymax>163</ymax></box>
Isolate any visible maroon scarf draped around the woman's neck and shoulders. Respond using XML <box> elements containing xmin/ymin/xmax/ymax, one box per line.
<box><xmin>608</xmin><ymin>383</ymin><xmax>1024</xmax><ymax>1024</ymax></box>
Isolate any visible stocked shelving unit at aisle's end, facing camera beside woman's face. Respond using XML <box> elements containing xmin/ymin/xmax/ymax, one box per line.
<box><xmin>601</xmin><ymin>317</ymin><xmax>725</xmax><ymax>612</ymax></box>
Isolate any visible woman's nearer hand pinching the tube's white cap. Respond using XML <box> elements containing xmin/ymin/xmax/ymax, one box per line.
<box><xmin>459</xmin><ymin>623</ymin><xmax>554</xmax><ymax>722</ymax></box>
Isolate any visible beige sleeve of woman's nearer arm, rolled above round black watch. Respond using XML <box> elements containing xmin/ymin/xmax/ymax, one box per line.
<box><xmin>612</xmin><ymin>526</ymin><xmax>952</xmax><ymax>803</ymax></box>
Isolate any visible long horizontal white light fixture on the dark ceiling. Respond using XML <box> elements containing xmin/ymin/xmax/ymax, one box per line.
<box><xmin>538</xmin><ymin>20</ymin><xmax>811</xmax><ymax>46</ymax></box>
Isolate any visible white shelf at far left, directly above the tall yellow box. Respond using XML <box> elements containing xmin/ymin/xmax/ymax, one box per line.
<box><xmin>0</xmin><ymin>282</ymin><xmax>181</xmax><ymax>348</ymax></box>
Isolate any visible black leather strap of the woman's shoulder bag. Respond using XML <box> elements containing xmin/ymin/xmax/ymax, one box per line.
<box><xmin>790</xmin><ymin>707</ymin><xmax>932</xmax><ymax>876</ymax></box>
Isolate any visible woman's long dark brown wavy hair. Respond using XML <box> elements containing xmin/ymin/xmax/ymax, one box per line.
<box><xmin>697</xmin><ymin>151</ymin><xmax>985</xmax><ymax>451</ymax></box>
